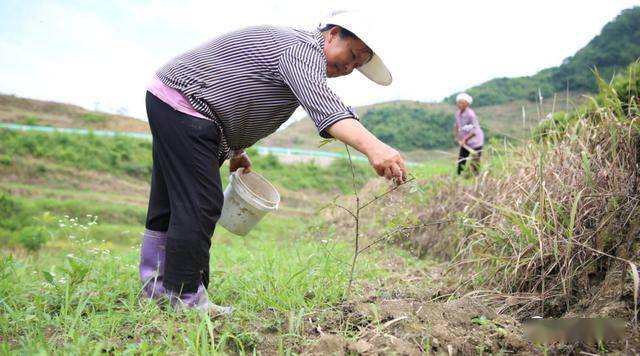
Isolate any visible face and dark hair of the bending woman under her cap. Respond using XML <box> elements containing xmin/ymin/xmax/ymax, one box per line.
<box><xmin>324</xmin><ymin>26</ymin><xmax>372</xmax><ymax>78</ymax></box>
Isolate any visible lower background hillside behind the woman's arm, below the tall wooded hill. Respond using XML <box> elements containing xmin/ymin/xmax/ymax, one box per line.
<box><xmin>261</xmin><ymin>93</ymin><xmax>587</xmax><ymax>160</ymax></box>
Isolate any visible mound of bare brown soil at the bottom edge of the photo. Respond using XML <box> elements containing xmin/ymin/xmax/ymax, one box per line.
<box><xmin>304</xmin><ymin>298</ymin><xmax>535</xmax><ymax>355</ymax></box>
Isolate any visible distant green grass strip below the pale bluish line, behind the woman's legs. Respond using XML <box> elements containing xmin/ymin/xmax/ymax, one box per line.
<box><xmin>0</xmin><ymin>130</ymin><xmax>374</xmax><ymax>192</ymax></box>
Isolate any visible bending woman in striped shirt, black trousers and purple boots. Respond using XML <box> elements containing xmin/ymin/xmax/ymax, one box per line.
<box><xmin>140</xmin><ymin>12</ymin><xmax>407</xmax><ymax>314</ymax></box>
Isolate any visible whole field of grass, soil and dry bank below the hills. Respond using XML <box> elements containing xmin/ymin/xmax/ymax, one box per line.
<box><xmin>0</xmin><ymin>64</ymin><xmax>640</xmax><ymax>355</ymax></box>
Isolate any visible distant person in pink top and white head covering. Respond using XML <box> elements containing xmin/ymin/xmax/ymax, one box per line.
<box><xmin>453</xmin><ymin>93</ymin><xmax>484</xmax><ymax>175</ymax></box>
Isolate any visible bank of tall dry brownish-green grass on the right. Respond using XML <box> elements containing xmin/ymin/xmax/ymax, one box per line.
<box><xmin>336</xmin><ymin>66</ymin><xmax>640</xmax><ymax>326</ymax></box>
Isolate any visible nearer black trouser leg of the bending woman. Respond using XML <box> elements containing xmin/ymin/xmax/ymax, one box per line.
<box><xmin>147</xmin><ymin>93</ymin><xmax>224</xmax><ymax>295</ymax></box>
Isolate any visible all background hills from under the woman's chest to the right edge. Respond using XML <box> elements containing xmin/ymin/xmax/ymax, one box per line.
<box><xmin>262</xmin><ymin>7</ymin><xmax>640</xmax><ymax>153</ymax></box>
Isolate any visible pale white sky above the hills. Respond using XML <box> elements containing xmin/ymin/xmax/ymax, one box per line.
<box><xmin>0</xmin><ymin>0</ymin><xmax>640</xmax><ymax>120</ymax></box>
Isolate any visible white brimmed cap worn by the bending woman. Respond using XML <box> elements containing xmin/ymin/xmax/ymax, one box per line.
<box><xmin>320</xmin><ymin>11</ymin><xmax>392</xmax><ymax>85</ymax></box>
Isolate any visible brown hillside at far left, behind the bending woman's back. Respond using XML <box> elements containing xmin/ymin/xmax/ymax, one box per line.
<box><xmin>0</xmin><ymin>95</ymin><xmax>149</xmax><ymax>133</ymax></box>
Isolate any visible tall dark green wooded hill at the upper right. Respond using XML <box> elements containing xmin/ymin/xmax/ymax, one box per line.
<box><xmin>445</xmin><ymin>7</ymin><xmax>640</xmax><ymax>106</ymax></box>
